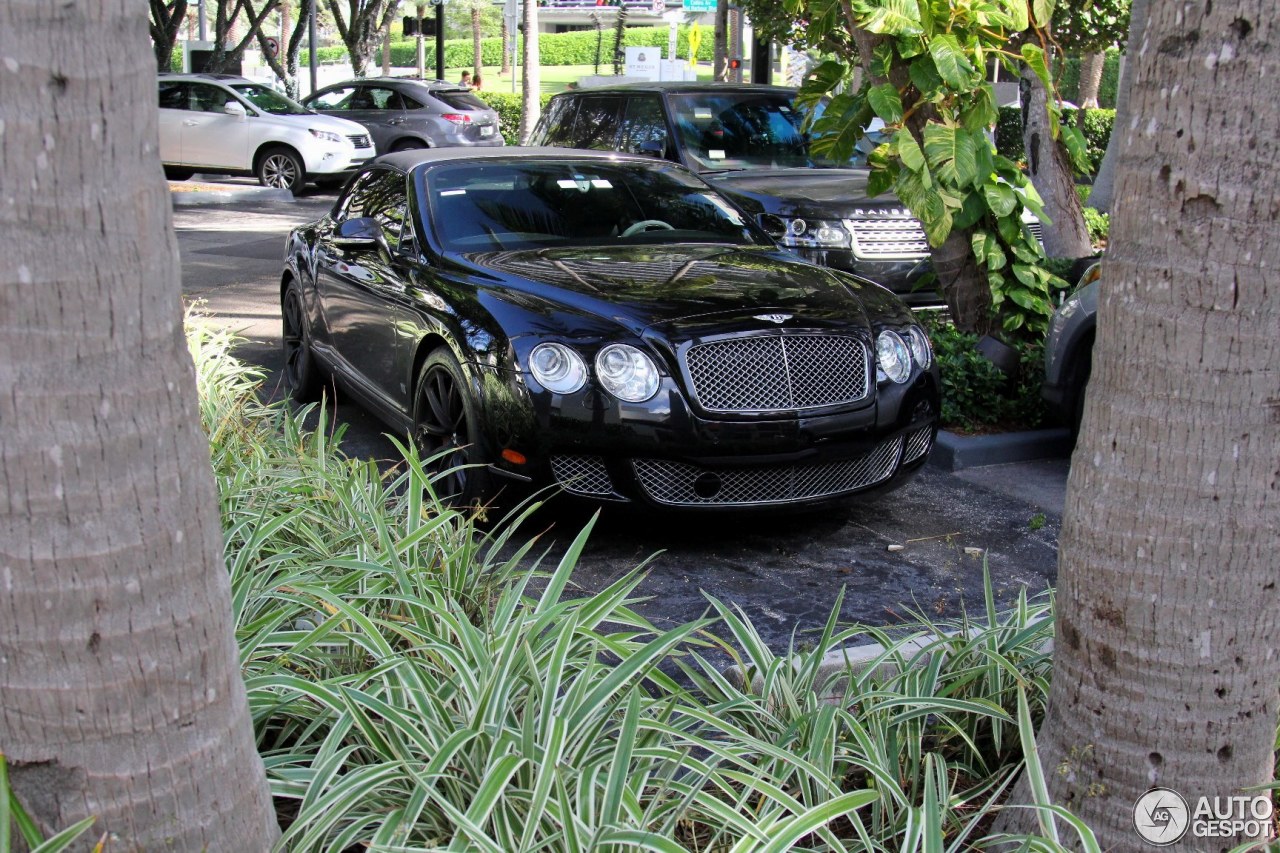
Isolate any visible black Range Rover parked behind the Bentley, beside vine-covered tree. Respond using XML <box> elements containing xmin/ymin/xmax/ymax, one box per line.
<box><xmin>529</xmin><ymin>82</ymin><xmax>941</xmax><ymax>306</ymax></box>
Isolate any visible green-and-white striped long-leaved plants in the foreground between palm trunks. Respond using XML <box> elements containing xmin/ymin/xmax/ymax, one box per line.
<box><xmin>188</xmin><ymin>317</ymin><xmax>1097</xmax><ymax>853</ymax></box>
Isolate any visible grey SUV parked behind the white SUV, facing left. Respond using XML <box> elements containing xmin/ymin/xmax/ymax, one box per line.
<box><xmin>302</xmin><ymin>77</ymin><xmax>503</xmax><ymax>154</ymax></box>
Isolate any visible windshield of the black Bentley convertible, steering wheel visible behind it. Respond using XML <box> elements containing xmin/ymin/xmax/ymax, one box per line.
<box><xmin>425</xmin><ymin>160</ymin><xmax>772</xmax><ymax>252</ymax></box>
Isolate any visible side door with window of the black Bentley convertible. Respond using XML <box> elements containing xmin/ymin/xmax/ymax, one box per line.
<box><xmin>316</xmin><ymin>169</ymin><xmax>406</xmax><ymax>402</ymax></box>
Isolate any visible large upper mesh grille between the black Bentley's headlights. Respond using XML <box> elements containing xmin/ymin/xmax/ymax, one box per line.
<box><xmin>685</xmin><ymin>334</ymin><xmax>869</xmax><ymax>412</ymax></box>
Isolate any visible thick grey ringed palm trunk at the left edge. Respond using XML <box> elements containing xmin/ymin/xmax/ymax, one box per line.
<box><xmin>0</xmin><ymin>0</ymin><xmax>279</xmax><ymax>852</ymax></box>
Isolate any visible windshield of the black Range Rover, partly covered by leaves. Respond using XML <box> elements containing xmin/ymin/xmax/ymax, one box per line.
<box><xmin>671</xmin><ymin>91</ymin><xmax>874</xmax><ymax>170</ymax></box>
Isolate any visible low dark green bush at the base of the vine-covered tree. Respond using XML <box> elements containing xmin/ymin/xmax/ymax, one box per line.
<box><xmin>929</xmin><ymin>313</ymin><xmax>1048</xmax><ymax>433</ymax></box>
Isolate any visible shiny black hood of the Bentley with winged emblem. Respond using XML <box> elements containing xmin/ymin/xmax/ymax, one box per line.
<box><xmin>462</xmin><ymin>243</ymin><xmax>909</xmax><ymax>341</ymax></box>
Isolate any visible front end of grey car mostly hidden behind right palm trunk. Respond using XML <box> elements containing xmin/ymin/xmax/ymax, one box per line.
<box><xmin>1041</xmin><ymin>261</ymin><xmax>1102</xmax><ymax>435</ymax></box>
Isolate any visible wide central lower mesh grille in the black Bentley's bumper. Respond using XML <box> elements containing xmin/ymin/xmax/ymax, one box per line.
<box><xmin>632</xmin><ymin>437</ymin><xmax>902</xmax><ymax>506</ymax></box>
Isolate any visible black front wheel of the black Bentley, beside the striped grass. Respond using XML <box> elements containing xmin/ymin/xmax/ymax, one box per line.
<box><xmin>413</xmin><ymin>347</ymin><xmax>489</xmax><ymax>506</ymax></box>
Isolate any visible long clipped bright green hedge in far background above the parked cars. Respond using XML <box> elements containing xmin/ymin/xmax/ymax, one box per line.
<box><xmin>298</xmin><ymin>27</ymin><xmax>713</xmax><ymax>70</ymax></box>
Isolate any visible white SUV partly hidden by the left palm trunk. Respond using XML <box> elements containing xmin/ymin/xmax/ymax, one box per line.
<box><xmin>160</xmin><ymin>74</ymin><xmax>374</xmax><ymax>192</ymax></box>
